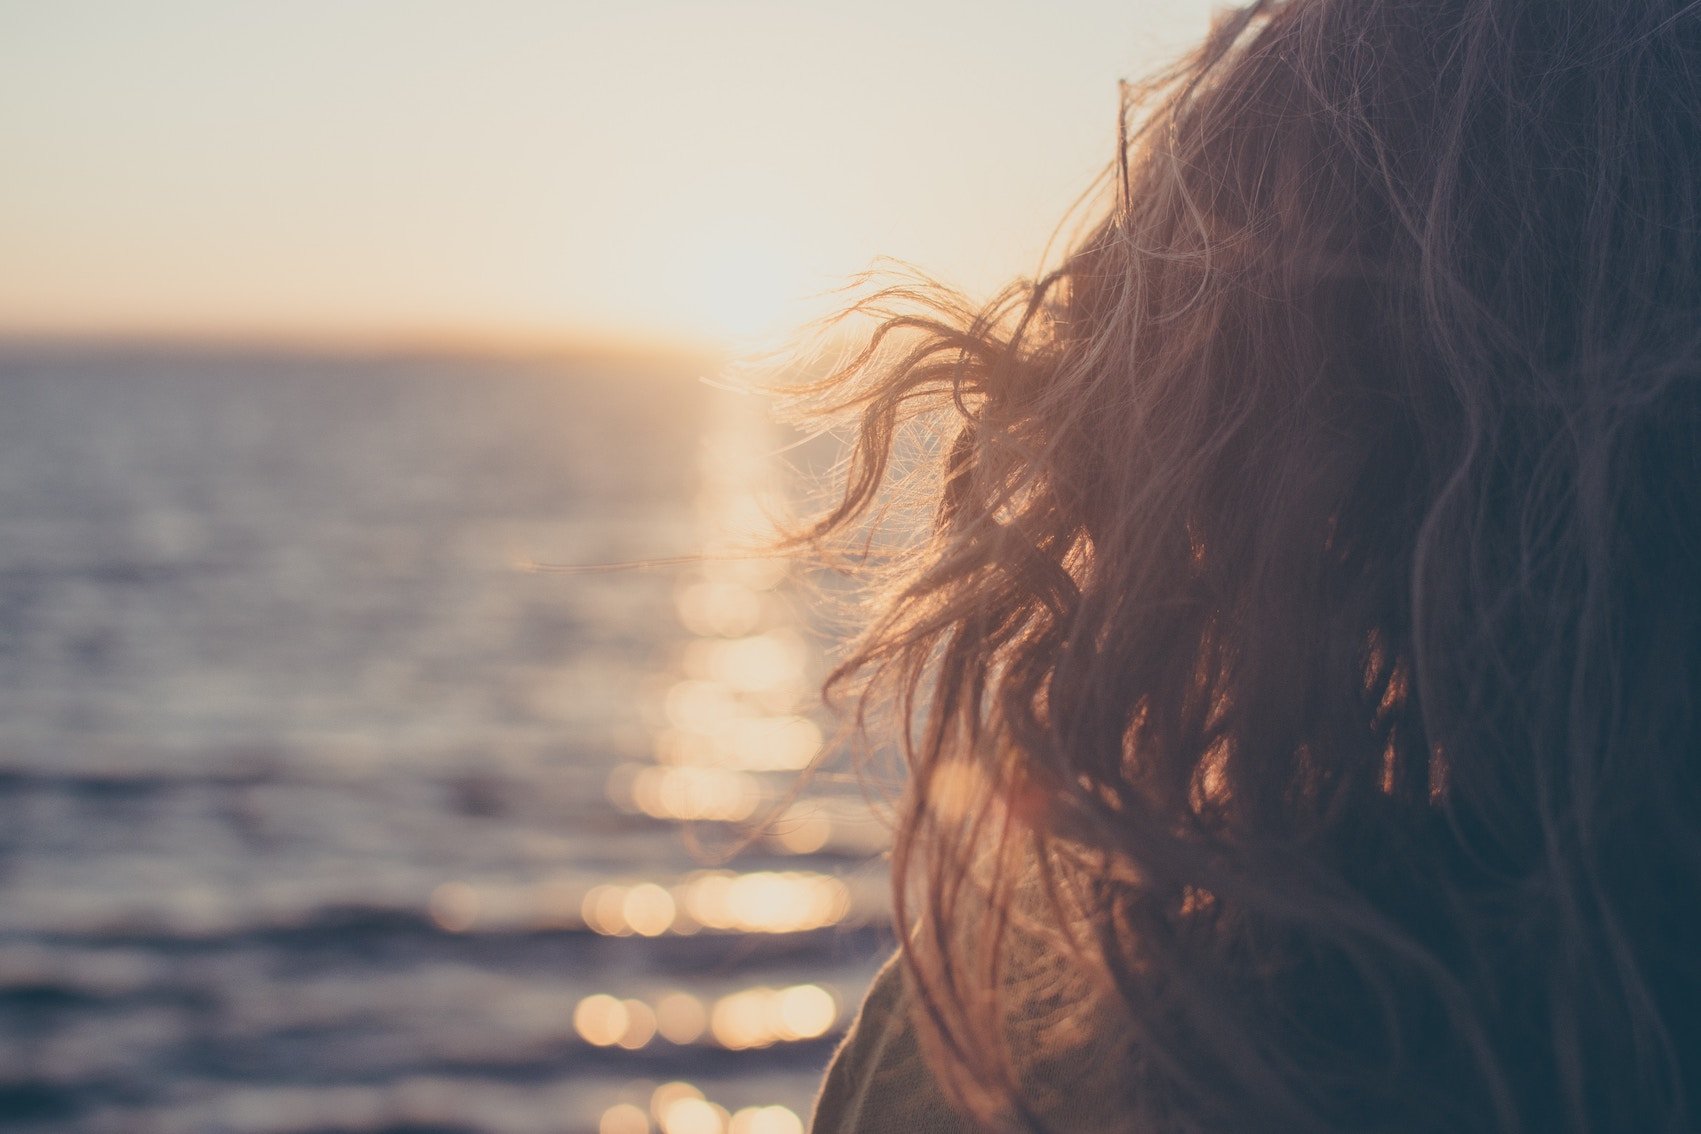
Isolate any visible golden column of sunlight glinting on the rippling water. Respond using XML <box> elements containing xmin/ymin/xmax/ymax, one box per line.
<box><xmin>573</xmin><ymin>385</ymin><xmax>886</xmax><ymax>1134</ymax></box>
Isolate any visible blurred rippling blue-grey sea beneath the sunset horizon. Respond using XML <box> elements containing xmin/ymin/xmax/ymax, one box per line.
<box><xmin>0</xmin><ymin>349</ymin><xmax>890</xmax><ymax>1134</ymax></box>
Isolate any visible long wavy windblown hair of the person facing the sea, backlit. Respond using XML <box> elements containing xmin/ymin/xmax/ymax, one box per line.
<box><xmin>789</xmin><ymin>0</ymin><xmax>1701</xmax><ymax>1132</ymax></box>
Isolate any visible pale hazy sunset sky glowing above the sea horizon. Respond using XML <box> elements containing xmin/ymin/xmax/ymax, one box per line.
<box><xmin>0</xmin><ymin>0</ymin><xmax>1218</xmax><ymax>345</ymax></box>
